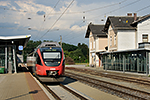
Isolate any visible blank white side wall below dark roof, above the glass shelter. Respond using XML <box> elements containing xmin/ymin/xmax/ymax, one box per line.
<box><xmin>117</xmin><ymin>30</ymin><xmax>136</xmax><ymax>51</ymax></box>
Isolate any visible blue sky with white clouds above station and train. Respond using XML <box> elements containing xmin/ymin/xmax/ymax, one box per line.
<box><xmin>0</xmin><ymin>0</ymin><xmax>150</xmax><ymax>45</ymax></box>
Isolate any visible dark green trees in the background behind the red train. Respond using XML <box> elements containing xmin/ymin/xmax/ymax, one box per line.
<box><xmin>23</xmin><ymin>40</ymin><xmax>89</xmax><ymax>63</ymax></box>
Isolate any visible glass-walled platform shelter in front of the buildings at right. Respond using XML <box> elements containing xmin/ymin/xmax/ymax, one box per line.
<box><xmin>100</xmin><ymin>48</ymin><xmax>150</xmax><ymax>75</ymax></box>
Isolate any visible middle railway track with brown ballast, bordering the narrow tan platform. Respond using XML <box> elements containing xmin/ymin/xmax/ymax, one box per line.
<box><xmin>65</xmin><ymin>72</ymin><xmax>150</xmax><ymax>100</ymax></box>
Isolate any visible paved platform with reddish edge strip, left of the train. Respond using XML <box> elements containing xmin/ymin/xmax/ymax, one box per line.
<box><xmin>0</xmin><ymin>72</ymin><xmax>49</xmax><ymax>100</ymax></box>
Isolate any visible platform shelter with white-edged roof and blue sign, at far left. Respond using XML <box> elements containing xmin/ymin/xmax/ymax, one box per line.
<box><xmin>0</xmin><ymin>35</ymin><xmax>31</xmax><ymax>73</ymax></box>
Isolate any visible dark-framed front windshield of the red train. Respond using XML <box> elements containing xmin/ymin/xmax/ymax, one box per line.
<box><xmin>42</xmin><ymin>48</ymin><xmax>62</xmax><ymax>66</ymax></box>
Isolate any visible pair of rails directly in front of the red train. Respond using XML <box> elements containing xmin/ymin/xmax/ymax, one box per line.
<box><xmin>43</xmin><ymin>83</ymin><xmax>88</xmax><ymax>100</ymax></box>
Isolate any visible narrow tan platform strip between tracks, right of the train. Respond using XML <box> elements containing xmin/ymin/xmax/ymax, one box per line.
<box><xmin>63</xmin><ymin>78</ymin><xmax>123</xmax><ymax>100</ymax></box>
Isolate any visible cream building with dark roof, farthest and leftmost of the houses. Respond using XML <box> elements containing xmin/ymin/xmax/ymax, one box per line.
<box><xmin>85</xmin><ymin>23</ymin><xmax>108</xmax><ymax>67</ymax></box>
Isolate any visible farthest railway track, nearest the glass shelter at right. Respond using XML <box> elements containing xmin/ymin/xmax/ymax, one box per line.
<box><xmin>66</xmin><ymin>68</ymin><xmax>150</xmax><ymax>86</ymax></box>
